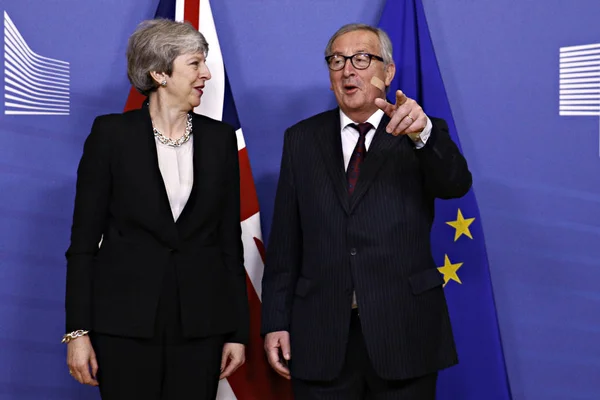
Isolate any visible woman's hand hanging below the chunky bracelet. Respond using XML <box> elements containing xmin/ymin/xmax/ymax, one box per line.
<box><xmin>67</xmin><ymin>335</ymin><xmax>98</xmax><ymax>386</ymax></box>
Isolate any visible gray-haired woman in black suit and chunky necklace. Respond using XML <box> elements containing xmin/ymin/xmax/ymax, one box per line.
<box><xmin>64</xmin><ymin>20</ymin><xmax>249</xmax><ymax>400</ymax></box>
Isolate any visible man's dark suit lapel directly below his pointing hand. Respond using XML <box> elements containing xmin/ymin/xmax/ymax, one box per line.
<box><xmin>349</xmin><ymin>115</ymin><xmax>403</xmax><ymax>212</ymax></box>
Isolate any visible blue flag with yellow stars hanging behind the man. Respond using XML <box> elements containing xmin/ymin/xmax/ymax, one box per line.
<box><xmin>379</xmin><ymin>0</ymin><xmax>511</xmax><ymax>400</ymax></box>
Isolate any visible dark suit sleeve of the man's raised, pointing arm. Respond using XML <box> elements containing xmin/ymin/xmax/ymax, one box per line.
<box><xmin>416</xmin><ymin>118</ymin><xmax>473</xmax><ymax>199</ymax></box>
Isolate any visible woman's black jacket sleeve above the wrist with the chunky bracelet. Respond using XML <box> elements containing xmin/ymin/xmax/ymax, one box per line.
<box><xmin>65</xmin><ymin>117</ymin><xmax>112</xmax><ymax>332</ymax></box>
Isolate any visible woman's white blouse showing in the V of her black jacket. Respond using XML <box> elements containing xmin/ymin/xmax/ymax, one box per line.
<box><xmin>154</xmin><ymin>136</ymin><xmax>194</xmax><ymax>221</ymax></box>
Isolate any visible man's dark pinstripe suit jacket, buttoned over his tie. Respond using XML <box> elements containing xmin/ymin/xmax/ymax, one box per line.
<box><xmin>262</xmin><ymin>109</ymin><xmax>471</xmax><ymax>380</ymax></box>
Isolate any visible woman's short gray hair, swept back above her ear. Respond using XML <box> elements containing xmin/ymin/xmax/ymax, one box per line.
<box><xmin>127</xmin><ymin>18</ymin><xmax>208</xmax><ymax>96</ymax></box>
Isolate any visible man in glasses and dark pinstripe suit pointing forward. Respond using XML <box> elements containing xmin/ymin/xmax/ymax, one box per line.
<box><xmin>262</xmin><ymin>24</ymin><xmax>471</xmax><ymax>400</ymax></box>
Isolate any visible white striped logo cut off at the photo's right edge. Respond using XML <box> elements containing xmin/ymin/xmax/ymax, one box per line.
<box><xmin>559</xmin><ymin>43</ymin><xmax>600</xmax><ymax>152</ymax></box>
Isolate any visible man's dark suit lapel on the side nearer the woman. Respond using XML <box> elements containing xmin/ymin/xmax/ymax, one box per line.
<box><xmin>315</xmin><ymin>109</ymin><xmax>350</xmax><ymax>213</ymax></box>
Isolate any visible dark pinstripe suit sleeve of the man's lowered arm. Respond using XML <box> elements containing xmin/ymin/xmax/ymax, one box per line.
<box><xmin>261</xmin><ymin>130</ymin><xmax>302</xmax><ymax>335</ymax></box>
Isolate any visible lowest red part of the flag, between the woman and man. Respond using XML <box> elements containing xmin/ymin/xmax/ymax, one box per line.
<box><xmin>227</xmin><ymin>276</ymin><xmax>293</xmax><ymax>400</ymax></box>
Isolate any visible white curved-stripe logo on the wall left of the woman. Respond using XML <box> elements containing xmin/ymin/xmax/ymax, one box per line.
<box><xmin>4</xmin><ymin>11</ymin><xmax>70</xmax><ymax>115</ymax></box>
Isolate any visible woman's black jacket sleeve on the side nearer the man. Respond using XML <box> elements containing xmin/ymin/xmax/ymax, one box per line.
<box><xmin>220</xmin><ymin>130</ymin><xmax>250</xmax><ymax>344</ymax></box>
